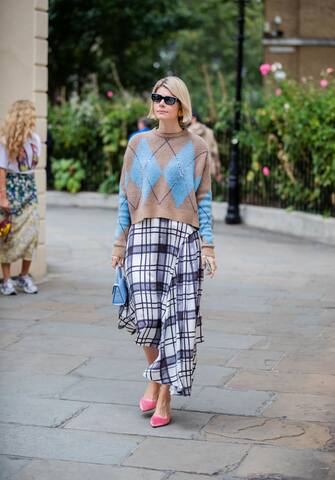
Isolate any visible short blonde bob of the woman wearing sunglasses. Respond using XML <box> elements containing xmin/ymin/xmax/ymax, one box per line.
<box><xmin>148</xmin><ymin>77</ymin><xmax>192</xmax><ymax>127</ymax></box>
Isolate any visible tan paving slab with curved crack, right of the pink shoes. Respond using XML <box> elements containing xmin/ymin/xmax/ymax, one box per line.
<box><xmin>200</xmin><ymin>415</ymin><xmax>333</xmax><ymax>449</ymax></box>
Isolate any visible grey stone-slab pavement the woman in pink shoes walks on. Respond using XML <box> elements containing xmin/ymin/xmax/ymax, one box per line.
<box><xmin>0</xmin><ymin>208</ymin><xmax>335</xmax><ymax>480</ymax></box>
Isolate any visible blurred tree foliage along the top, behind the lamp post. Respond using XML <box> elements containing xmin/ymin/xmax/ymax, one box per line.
<box><xmin>49</xmin><ymin>0</ymin><xmax>263</xmax><ymax>110</ymax></box>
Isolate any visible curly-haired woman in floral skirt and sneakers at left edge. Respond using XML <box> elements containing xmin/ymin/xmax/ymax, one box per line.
<box><xmin>0</xmin><ymin>100</ymin><xmax>41</xmax><ymax>295</ymax></box>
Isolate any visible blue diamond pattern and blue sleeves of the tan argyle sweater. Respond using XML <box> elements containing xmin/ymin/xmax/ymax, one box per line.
<box><xmin>115</xmin><ymin>132</ymin><xmax>213</xmax><ymax>251</ymax></box>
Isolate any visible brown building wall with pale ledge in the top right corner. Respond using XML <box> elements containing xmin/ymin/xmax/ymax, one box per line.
<box><xmin>263</xmin><ymin>0</ymin><xmax>335</xmax><ymax>79</ymax></box>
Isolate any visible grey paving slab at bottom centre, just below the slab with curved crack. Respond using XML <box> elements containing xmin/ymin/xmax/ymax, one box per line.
<box><xmin>123</xmin><ymin>438</ymin><xmax>249</xmax><ymax>475</ymax></box>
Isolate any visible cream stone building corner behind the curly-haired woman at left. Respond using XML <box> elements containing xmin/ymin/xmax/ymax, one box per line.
<box><xmin>0</xmin><ymin>0</ymin><xmax>48</xmax><ymax>279</ymax></box>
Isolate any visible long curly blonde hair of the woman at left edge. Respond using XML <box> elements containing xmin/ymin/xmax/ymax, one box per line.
<box><xmin>0</xmin><ymin>100</ymin><xmax>36</xmax><ymax>160</ymax></box>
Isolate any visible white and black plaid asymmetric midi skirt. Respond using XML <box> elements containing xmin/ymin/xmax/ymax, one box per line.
<box><xmin>118</xmin><ymin>218</ymin><xmax>203</xmax><ymax>396</ymax></box>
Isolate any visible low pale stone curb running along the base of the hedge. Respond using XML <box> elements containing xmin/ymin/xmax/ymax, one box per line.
<box><xmin>46</xmin><ymin>190</ymin><xmax>335</xmax><ymax>246</ymax></box>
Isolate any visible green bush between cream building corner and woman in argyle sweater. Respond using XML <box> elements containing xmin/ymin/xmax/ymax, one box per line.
<box><xmin>49</xmin><ymin>93</ymin><xmax>148</xmax><ymax>193</ymax></box>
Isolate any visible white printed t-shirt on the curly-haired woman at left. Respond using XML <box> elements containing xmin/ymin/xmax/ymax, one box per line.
<box><xmin>0</xmin><ymin>133</ymin><xmax>41</xmax><ymax>174</ymax></box>
